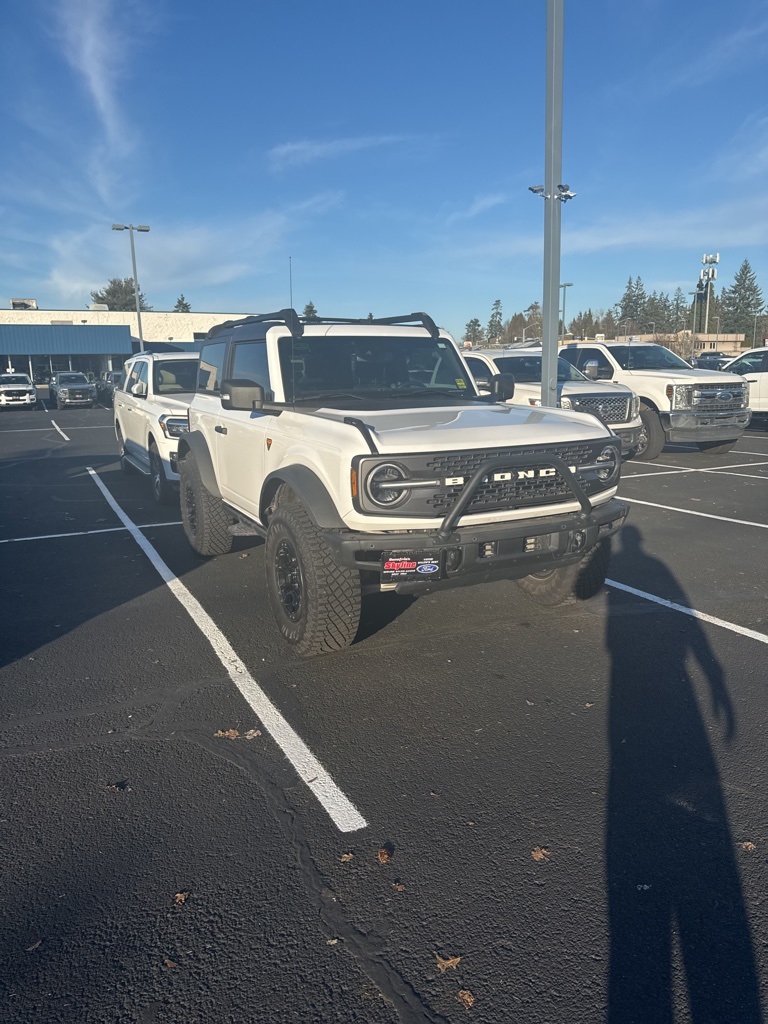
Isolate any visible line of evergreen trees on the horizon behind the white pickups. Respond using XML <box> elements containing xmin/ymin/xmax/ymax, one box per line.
<box><xmin>462</xmin><ymin>260</ymin><xmax>765</xmax><ymax>347</ymax></box>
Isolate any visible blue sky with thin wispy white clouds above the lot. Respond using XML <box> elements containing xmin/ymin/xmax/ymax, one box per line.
<box><xmin>0</xmin><ymin>0</ymin><xmax>768</xmax><ymax>335</ymax></box>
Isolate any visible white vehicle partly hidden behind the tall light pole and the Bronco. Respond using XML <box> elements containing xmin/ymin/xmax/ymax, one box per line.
<box><xmin>464</xmin><ymin>348</ymin><xmax>642</xmax><ymax>456</ymax></box>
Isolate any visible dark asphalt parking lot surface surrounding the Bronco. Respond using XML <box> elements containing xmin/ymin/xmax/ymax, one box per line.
<box><xmin>0</xmin><ymin>407</ymin><xmax>768</xmax><ymax>1024</ymax></box>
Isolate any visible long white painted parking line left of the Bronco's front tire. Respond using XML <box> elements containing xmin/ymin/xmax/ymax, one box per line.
<box><xmin>86</xmin><ymin>466</ymin><xmax>368</xmax><ymax>833</ymax></box>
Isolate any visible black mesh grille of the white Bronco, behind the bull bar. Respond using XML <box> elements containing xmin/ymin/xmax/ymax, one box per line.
<box><xmin>426</xmin><ymin>444</ymin><xmax>605</xmax><ymax>515</ymax></box>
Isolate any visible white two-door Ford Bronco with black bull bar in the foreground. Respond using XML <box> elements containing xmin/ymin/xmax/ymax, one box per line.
<box><xmin>178</xmin><ymin>309</ymin><xmax>627</xmax><ymax>655</ymax></box>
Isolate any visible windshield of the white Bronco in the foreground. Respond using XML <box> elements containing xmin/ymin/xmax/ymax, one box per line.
<box><xmin>279</xmin><ymin>335</ymin><xmax>477</xmax><ymax>401</ymax></box>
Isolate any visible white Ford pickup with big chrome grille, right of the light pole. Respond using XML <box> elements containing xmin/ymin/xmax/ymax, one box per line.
<box><xmin>560</xmin><ymin>341</ymin><xmax>752</xmax><ymax>462</ymax></box>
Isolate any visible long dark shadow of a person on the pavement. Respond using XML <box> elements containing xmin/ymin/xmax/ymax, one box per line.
<box><xmin>606</xmin><ymin>526</ymin><xmax>763</xmax><ymax>1024</ymax></box>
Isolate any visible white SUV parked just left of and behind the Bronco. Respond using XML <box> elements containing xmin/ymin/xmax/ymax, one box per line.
<box><xmin>114</xmin><ymin>352</ymin><xmax>199</xmax><ymax>505</ymax></box>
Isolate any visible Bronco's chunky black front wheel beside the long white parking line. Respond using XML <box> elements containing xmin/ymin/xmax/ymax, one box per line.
<box><xmin>265</xmin><ymin>503</ymin><xmax>360</xmax><ymax>657</ymax></box>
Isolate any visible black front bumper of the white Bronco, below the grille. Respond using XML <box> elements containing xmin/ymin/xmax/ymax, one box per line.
<box><xmin>323</xmin><ymin>498</ymin><xmax>629</xmax><ymax>594</ymax></box>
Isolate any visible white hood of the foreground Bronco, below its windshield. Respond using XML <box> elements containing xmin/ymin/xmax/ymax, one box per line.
<box><xmin>318</xmin><ymin>404</ymin><xmax>610</xmax><ymax>453</ymax></box>
